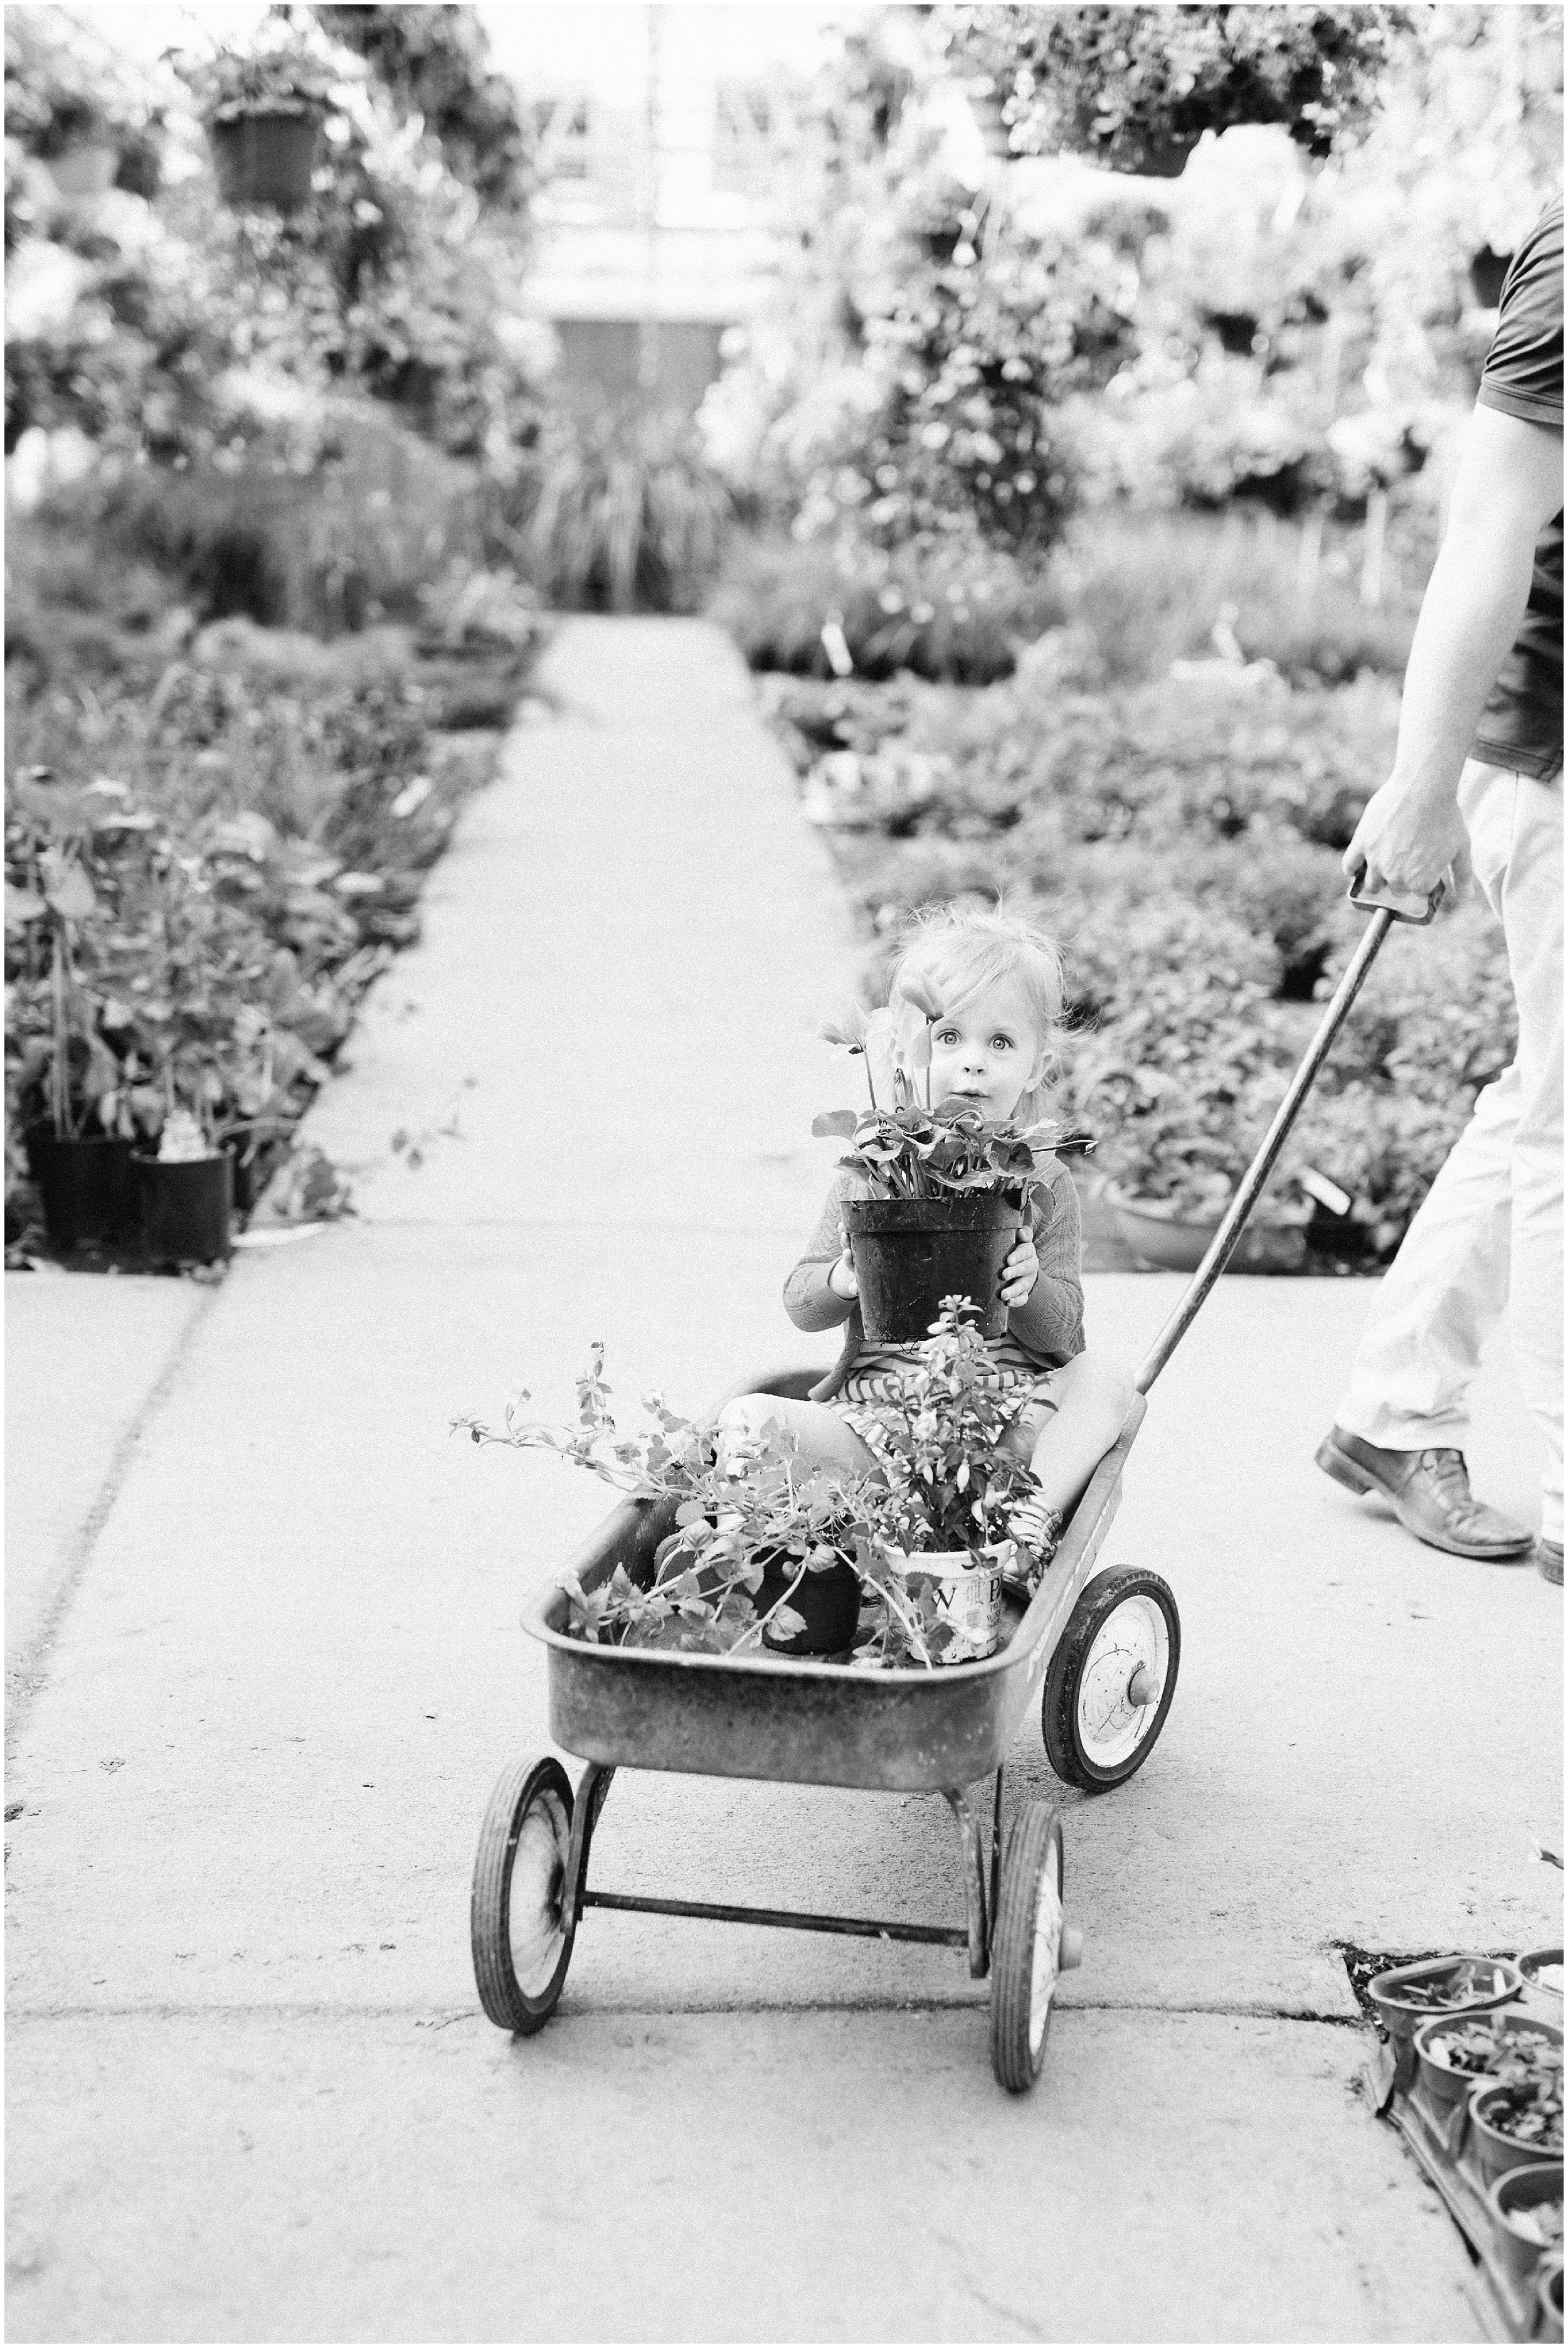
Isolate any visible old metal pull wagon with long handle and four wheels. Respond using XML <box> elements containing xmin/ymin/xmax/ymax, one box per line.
<box><xmin>472</xmin><ymin>890</ymin><xmax>1439</xmax><ymax>2092</ymax></box>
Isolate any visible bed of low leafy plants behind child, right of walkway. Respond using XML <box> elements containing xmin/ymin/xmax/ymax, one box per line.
<box><xmin>772</xmin><ymin>636</ymin><xmax>1514</xmax><ymax>1254</ymax></box>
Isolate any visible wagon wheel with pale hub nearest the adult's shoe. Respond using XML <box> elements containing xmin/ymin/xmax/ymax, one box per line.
<box><xmin>1040</xmin><ymin>1566</ymin><xmax>1180</xmax><ymax>1794</ymax></box>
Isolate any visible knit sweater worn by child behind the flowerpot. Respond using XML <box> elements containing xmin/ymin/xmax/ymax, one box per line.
<box><xmin>784</xmin><ymin>1157</ymin><xmax>1084</xmax><ymax>1402</ymax></box>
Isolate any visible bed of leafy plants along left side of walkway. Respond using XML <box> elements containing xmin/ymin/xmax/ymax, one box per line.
<box><xmin>7</xmin><ymin>596</ymin><xmax>539</xmax><ymax>1221</ymax></box>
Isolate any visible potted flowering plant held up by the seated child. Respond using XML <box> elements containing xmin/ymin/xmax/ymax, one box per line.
<box><xmin>812</xmin><ymin>986</ymin><xmax>1091</xmax><ymax>1346</ymax></box>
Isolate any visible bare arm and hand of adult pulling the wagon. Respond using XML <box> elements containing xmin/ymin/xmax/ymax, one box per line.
<box><xmin>1345</xmin><ymin>406</ymin><xmax>1564</xmax><ymax>897</ymax></box>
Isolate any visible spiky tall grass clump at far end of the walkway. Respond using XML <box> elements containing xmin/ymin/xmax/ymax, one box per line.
<box><xmin>504</xmin><ymin>406</ymin><xmax>730</xmax><ymax>610</ymax></box>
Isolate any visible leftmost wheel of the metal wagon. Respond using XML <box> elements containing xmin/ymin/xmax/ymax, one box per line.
<box><xmin>470</xmin><ymin>1756</ymin><xmax>573</xmax><ymax>2033</ymax></box>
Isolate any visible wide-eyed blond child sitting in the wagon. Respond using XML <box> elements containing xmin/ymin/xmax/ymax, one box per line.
<box><xmin>718</xmin><ymin>909</ymin><xmax>1131</xmax><ymax>1559</ymax></box>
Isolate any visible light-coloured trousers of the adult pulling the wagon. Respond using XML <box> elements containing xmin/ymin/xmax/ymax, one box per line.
<box><xmin>1338</xmin><ymin>761</ymin><xmax>1564</xmax><ymax>1540</ymax></box>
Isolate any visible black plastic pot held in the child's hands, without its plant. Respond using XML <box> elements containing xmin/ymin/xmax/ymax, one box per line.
<box><xmin>843</xmin><ymin>1191</ymin><xmax>1025</xmax><ymax>1346</ymax></box>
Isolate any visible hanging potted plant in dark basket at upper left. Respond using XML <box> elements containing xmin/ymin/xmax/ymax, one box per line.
<box><xmin>178</xmin><ymin>28</ymin><xmax>342</xmax><ymax>211</ymax></box>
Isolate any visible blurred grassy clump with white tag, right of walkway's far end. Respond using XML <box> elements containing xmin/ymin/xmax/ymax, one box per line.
<box><xmin>709</xmin><ymin>535</ymin><xmax>1061</xmax><ymax>686</ymax></box>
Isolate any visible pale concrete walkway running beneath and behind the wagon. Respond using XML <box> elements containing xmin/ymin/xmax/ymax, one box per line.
<box><xmin>7</xmin><ymin>620</ymin><xmax>1561</xmax><ymax>2341</ymax></box>
